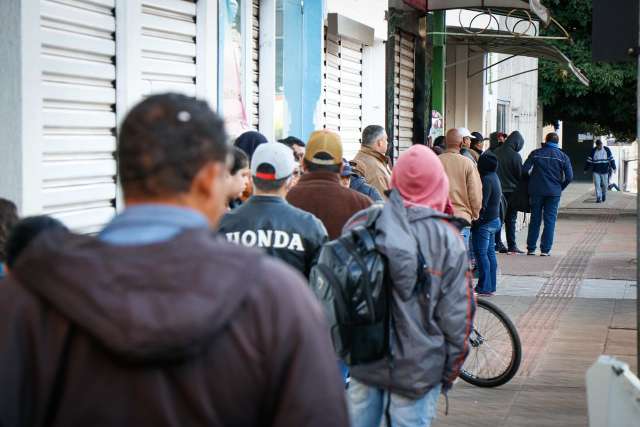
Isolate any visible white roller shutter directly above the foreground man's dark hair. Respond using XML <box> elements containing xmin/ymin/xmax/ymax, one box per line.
<box><xmin>141</xmin><ymin>0</ymin><xmax>196</xmax><ymax>96</ymax></box>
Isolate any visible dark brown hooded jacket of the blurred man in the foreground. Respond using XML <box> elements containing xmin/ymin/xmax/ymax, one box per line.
<box><xmin>0</xmin><ymin>230</ymin><xmax>348</xmax><ymax>427</ymax></box>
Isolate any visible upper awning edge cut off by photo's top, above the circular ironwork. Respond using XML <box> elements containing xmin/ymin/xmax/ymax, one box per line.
<box><xmin>404</xmin><ymin>0</ymin><xmax>551</xmax><ymax>25</ymax></box>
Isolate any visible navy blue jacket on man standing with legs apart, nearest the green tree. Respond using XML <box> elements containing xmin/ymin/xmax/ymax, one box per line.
<box><xmin>522</xmin><ymin>142</ymin><xmax>573</xmax><ymax>196</ymax></box>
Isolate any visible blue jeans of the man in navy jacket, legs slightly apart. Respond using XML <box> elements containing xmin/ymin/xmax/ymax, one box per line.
<box><xmin>527</xmin><ymin>196</ymin><xmax>560</xmax><ymax>253</ymax></box>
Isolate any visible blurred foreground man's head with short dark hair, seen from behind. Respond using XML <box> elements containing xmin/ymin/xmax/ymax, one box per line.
<box><xmin>118</xmin><ymin>93</ymin><xmax>230</xmax><ymax>226</ymax></box>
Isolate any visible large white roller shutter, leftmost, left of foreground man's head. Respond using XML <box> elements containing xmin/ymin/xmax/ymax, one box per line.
<box><xmin>40</xmin><ymin>0</ymin><xmax>116</xmax><ymax>233</ymax></box>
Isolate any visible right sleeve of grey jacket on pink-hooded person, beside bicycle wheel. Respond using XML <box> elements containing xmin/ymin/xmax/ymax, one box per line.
<box><xmin>436</xmin><ymin>236</ymin><xmax>476</xmax><ymax>388</ymax></box>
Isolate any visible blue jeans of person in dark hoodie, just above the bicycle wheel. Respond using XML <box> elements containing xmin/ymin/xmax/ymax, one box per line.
<box><xmin>472</xmin><ymin>218</ymin><xmax>501</xmax><ymax>293</ymax></box>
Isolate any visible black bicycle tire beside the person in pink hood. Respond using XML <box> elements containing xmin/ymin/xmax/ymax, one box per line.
<box><xmin>460</xmin><ymin>298</ymin><xmax>522</xmax><ymax>387</ymax></box>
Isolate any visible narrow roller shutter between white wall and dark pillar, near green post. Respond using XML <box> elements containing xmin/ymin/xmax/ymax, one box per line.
<box><xmin>393</xmin><ymin>32</ymin><xmax>415</xmax><ymax>158</ymax></box>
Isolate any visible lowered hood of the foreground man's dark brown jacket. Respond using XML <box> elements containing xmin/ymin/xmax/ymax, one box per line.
<box><xmin>13</xmin><ymin>229</ymin><xmax>260</xmax><ymax>362</ymax></box>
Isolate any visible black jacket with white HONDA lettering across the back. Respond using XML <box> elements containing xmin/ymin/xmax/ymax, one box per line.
<box><xmin>218</xmin><ymin>196</ymin><xmax>327</xmax><ymax>277</ymax></box>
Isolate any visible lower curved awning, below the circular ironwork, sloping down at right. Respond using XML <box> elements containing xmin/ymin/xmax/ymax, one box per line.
<box><xmin>447</xmin><ymin>31</ymin><xmax>589</xmax><ymax>86</ymax></box>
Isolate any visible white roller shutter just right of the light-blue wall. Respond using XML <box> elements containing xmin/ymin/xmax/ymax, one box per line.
<box><xmin>323</xmin><ymin>31</ymin><xmax>363</xmax><ymax>159</ymax></box>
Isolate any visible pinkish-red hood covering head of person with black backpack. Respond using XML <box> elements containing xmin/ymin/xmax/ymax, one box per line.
<box><xmin>391</xmin><ymin>145</ymin><xmax>449</xmax><ymax>212</ymax></box>
